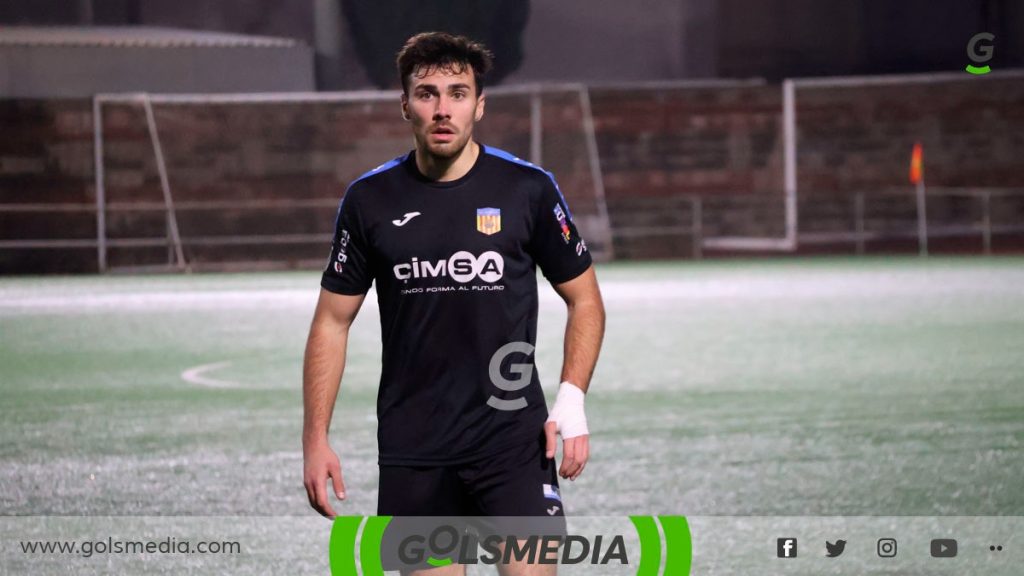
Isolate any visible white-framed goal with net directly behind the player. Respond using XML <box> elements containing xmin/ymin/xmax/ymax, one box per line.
<box><xmin>95</xmin><ymin>85</ymin><xmax>611</xmax><ymax>271</ymax></box>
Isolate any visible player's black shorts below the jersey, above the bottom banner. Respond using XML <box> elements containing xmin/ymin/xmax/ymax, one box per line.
<box><xmin>377</xmin><ymin>430</ymin><xmax>565</xmax><ymax>517</ymax></box>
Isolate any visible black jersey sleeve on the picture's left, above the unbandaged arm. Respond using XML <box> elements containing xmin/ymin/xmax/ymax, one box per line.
<box><xmin>321</xmin><ymin>188</ymin><xmax>373</xmax><ymax>296</ymax></box>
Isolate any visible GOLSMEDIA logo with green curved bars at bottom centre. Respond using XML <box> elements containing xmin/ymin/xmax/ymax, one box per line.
<box><xmin>330</xmin><ymin>516</ymin><xmax>692</xmax><ymax>576</ymax></box>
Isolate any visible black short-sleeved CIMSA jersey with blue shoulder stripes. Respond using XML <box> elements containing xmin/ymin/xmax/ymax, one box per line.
<box><xmin>321</xmin><ymin>146</ymin><xmax>591</xmax><ymax>465</ymax></box>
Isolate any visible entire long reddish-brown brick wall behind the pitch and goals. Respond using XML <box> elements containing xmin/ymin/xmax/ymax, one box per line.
<box><xmin>0</xmin><ymin>72</ymin><xmax>1024</xmax><ymax>273</ymax></box>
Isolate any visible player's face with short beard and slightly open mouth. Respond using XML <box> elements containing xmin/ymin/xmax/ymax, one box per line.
<box><xmin>401</xmin><ymin>66</ymin><xmax>483</xmax><ymax>159</ymax></box>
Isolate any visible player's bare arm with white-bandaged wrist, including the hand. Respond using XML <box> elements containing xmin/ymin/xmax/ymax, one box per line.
<box><xmin>545</xmin><ymin>265</ymin><xmax>604</xmax><ymax>480</ymax></box>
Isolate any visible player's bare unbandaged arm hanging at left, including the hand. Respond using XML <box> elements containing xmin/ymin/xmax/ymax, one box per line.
<box><xmin>302</xmin><ymin>289</ymin><xmax>366</xmax><ymax>518</ymax></box>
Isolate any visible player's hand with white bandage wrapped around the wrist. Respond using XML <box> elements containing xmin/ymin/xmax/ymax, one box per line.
<box><xmin>544</xmin><ymin>382</ymin><xmax>590</xmax><ymax>480</ymax></box>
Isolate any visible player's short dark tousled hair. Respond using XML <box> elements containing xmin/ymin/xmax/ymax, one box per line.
<box><xmin>397</xmin><ymin>32</ymin><xmax>494</xmax><ymax>94</ymax></box>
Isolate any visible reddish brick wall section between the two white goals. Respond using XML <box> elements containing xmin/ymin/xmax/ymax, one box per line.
<box><xmin>591</xmin><ymin>81</ymin><xmax>783</xmax><ymax>257</ymax></box>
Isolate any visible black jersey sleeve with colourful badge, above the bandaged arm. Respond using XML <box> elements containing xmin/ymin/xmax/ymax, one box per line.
<box><xmin>529</xmin><ymin>175</ymin><xmax>593</xmax><ymax>284</ymax></box>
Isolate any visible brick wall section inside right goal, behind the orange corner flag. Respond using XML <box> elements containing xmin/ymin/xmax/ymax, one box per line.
<box><xmin>797</xmin><ymin>77</ymin><xmax>1024</xmax><ymax>241</ymax></box>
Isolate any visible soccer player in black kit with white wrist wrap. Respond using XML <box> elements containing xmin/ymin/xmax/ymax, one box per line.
<box><xmin>302</xmin><ymin>33</ymin><xmax>604</xmax><ymax>576</ymax></box>
